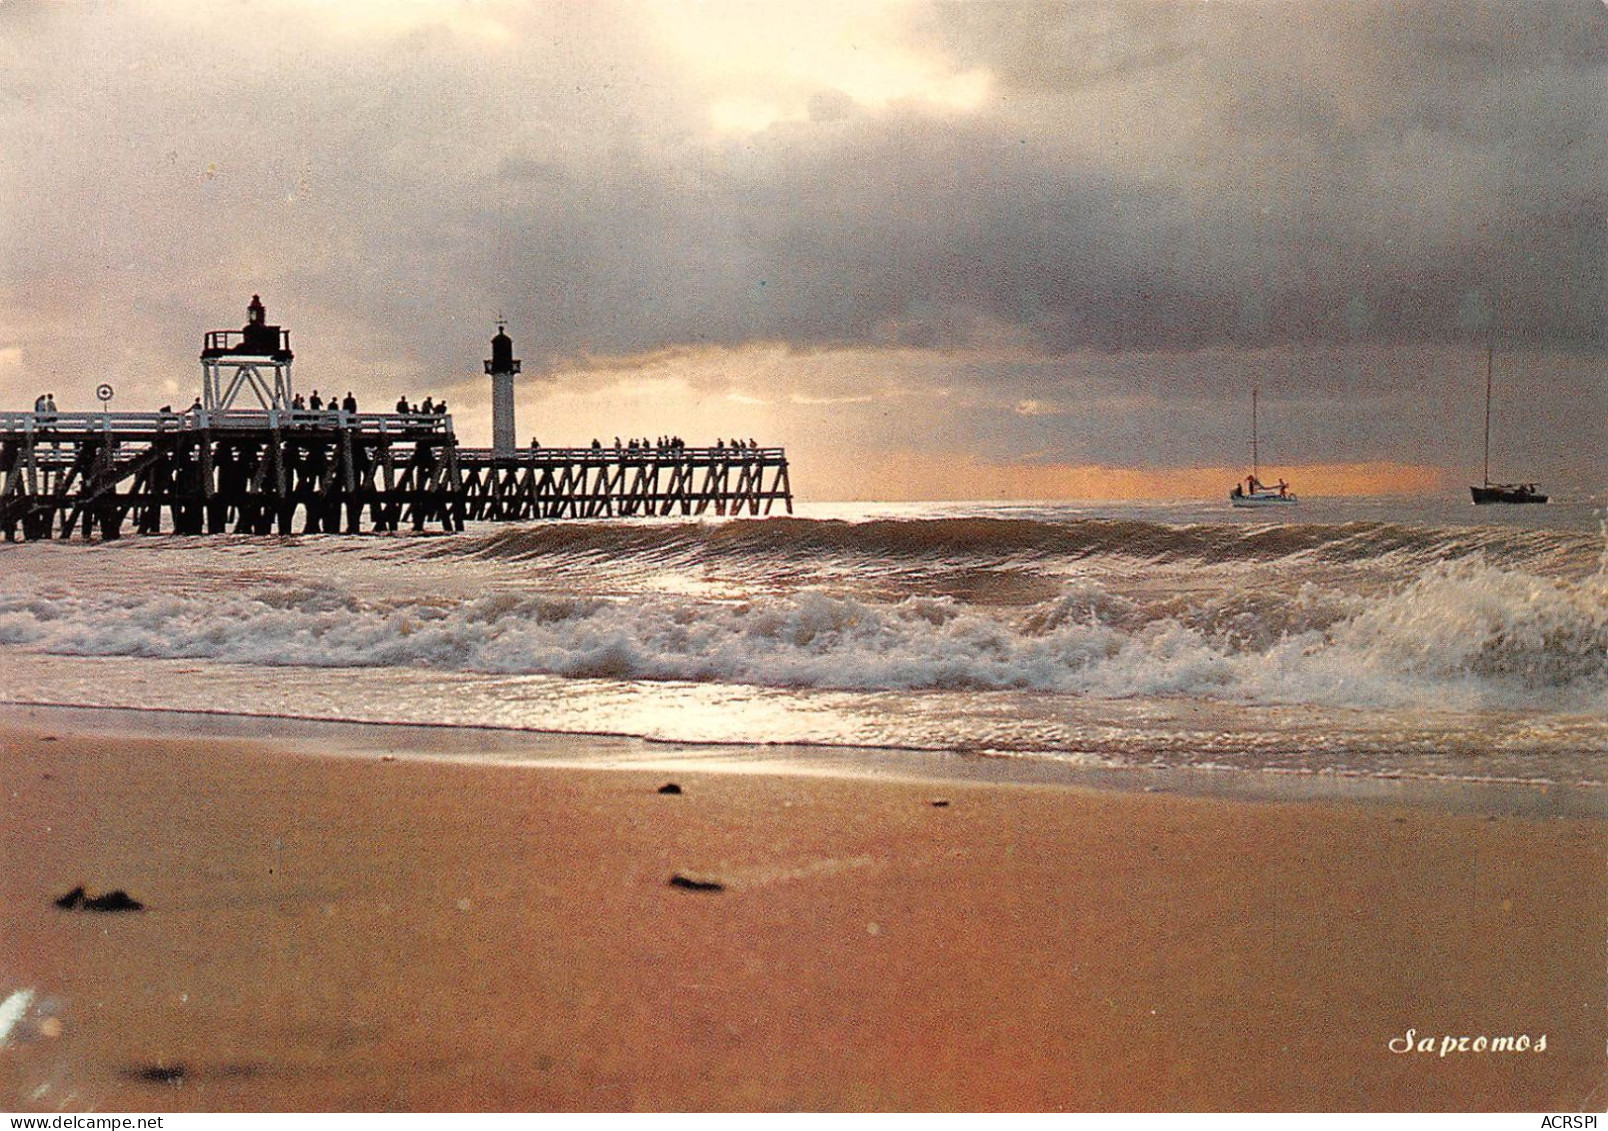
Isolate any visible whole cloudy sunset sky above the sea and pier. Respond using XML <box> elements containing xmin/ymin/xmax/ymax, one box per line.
<box><xmin>0</xmin><ymin>0</ymin><xmax>1608</xmax><ymax>499</ymax></box>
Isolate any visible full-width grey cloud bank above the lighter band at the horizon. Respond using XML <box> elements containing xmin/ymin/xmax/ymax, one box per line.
<box><xmin>0</xmin><ymin>0</ymin><xmax>1608</xmax><ymax>421</ymax></box>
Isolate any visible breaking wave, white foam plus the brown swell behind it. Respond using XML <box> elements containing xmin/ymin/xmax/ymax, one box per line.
<box><xmin>0</xmin><ymin>520</ymin><xmax>1608</xmax><ymax>711</ymax></box>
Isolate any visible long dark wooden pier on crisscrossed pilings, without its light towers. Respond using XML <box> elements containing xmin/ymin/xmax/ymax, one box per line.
<box><xmin>0</xmin><ymin>409</ymin><xmax>793</xmax><ymax>541</ymax></box>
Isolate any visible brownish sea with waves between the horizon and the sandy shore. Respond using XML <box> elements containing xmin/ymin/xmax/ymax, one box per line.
<box><xmin>0</xmin><ymin>496</ymin><xmax>1608</xmax><ymax>798</ymax></box>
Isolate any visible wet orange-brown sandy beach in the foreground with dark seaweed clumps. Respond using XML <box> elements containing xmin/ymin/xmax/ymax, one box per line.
<box><xmin>0</xmin><ymin>708</ymin><xmax>1608</xmax><ymax>1112</ymax></box>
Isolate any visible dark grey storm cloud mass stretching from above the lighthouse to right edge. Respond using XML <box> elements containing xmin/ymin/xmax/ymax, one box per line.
<box><xmin>427</xmin><ymin>3</ymin><xmax>1608</xmax><ymax>371</ymax></box>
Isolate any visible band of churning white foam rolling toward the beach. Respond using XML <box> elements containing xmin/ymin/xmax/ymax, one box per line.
<box><xmin>0</xmin><ymin>557</ymin><xmax>1608</xmax><ymax>709</ymax></box>
